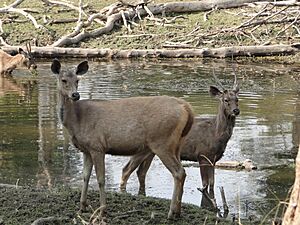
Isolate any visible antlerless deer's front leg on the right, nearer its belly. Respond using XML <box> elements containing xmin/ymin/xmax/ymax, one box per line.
<box><xmin>91</xmin><ymin>151</ymin><xmax>106</xmax><ymax>215</ymax></box>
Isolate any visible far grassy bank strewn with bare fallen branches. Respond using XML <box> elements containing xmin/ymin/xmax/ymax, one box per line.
<box><xmin>0</xmin><ymin>0</ymin><xmax>300</xmax><ymax>60</ymax></box>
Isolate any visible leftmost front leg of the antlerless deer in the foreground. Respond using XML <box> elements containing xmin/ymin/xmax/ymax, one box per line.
<box><xmin>80</xmin><ymin>153</ymin><xmax>93</xmax><ymax>211</ymax></box>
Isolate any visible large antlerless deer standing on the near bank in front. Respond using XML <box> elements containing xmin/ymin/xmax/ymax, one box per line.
<box><xmin>51</xmin><ymin>59</ymin><xmax>194</xmax><ymax>218</ymax></box>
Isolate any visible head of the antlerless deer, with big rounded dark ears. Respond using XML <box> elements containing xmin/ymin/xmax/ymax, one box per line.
<box><xmin>51</xmin><ymin>59</ymin><xmax>89</xmax><ymax>101</ymax></box>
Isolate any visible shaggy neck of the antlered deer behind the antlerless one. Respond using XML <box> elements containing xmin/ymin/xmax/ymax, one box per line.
<box><xmin>216</xmin><ymin>105</ymin><xmax>235</xmax><ymax>139</ymax></box>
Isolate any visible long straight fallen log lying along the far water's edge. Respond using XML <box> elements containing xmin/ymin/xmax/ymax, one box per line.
<box><xmin>2</xmin><ymin>43</ymin><xmax>300</xmax><ymax>58</ymax></box>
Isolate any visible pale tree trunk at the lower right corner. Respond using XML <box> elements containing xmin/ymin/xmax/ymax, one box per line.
<box><xmin>282</xmin><ymin>146</ymin><xmax>300</xmax><ymax>225</ymax></box>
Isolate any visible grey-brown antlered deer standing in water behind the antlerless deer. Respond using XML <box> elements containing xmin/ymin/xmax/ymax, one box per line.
<box><xmin>120</xmin><ymin>72</ymin><xmax>240</xmax><ymax>207</ymax></box>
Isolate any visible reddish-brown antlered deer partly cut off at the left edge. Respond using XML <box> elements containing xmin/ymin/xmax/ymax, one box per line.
<box><xmin>0</xmin><ymin>43</ymin><xmax>37</xmax><ymax>74</ymax></box>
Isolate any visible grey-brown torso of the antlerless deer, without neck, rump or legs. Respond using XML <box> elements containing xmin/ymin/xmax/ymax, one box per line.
<box><xmin>68</xmin><ymin>96</ymin><xmax>190</xmax><ymax>155</ymax></box>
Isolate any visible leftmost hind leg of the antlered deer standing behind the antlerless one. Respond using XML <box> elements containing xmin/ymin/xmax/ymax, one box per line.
<box><xmin>120</xmin><ymin>151</ymin><xmax>153</xmax><ymax>191</ymax></box>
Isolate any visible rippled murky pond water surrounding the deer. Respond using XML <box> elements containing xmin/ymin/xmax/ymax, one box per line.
<box><xmin>0</xmin><ymin>61</ymin><xmax>300</xmax><ymax>220</ymax></box>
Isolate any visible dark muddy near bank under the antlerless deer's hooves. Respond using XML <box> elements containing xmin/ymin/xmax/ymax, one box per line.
<box><xmin>0</xmin><ymin>187</ymin><xmax>259</xmax><ymax>225</ymax></box>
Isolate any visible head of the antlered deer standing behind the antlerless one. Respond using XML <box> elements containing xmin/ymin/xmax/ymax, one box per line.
<box><xmin>209</xmin><ymin>71</ymin><xmax>240</xmax><ymax>117</ymax></box>
